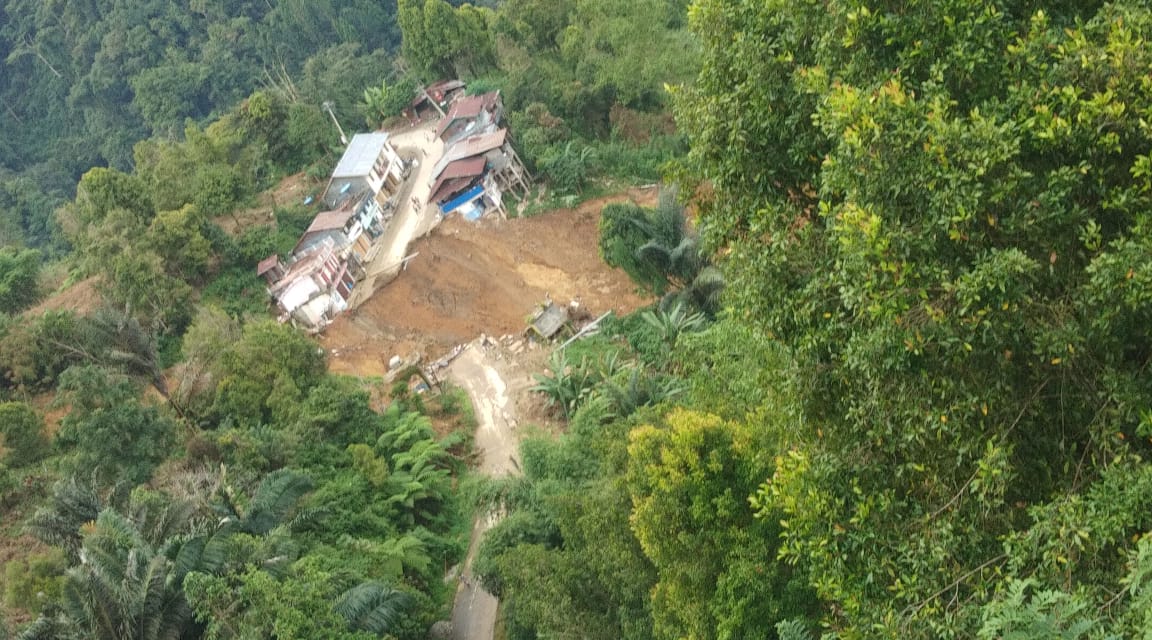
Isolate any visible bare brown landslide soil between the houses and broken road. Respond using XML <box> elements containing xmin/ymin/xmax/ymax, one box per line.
<box><xmin>318</xmin><ymin>189</ymin><xmax>657</xmax><ymax>376</ymax></box>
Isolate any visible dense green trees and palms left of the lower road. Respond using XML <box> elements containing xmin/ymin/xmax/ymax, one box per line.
<box><xmin>0</xmin><ymin>310</ymin><xmax>468</xmax><ymax>640</ymax></box>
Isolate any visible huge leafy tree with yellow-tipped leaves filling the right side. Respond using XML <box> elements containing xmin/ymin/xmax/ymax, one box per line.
<box><xmin>677</xmin><ymin>0</ymin><xmax>1152</xmax><ymax>638</ymax></box>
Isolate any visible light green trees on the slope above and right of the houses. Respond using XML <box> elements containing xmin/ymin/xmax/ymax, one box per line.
<box><xmin>440</xmin><ymin>0</ymin><xmax>696</xmax><ymax>193</ymax></box>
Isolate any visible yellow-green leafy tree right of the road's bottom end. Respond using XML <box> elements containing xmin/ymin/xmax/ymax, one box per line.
<box><xmin>628</xmin><ymin>411</ymin><xmax>816</xmax><ymax>639</ymax></box>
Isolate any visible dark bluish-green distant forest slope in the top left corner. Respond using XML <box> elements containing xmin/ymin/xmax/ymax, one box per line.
<box><xmin>0</xmin><ymin>0</ymin><xmax>400</xmax><ymax>246</ymax></box>
